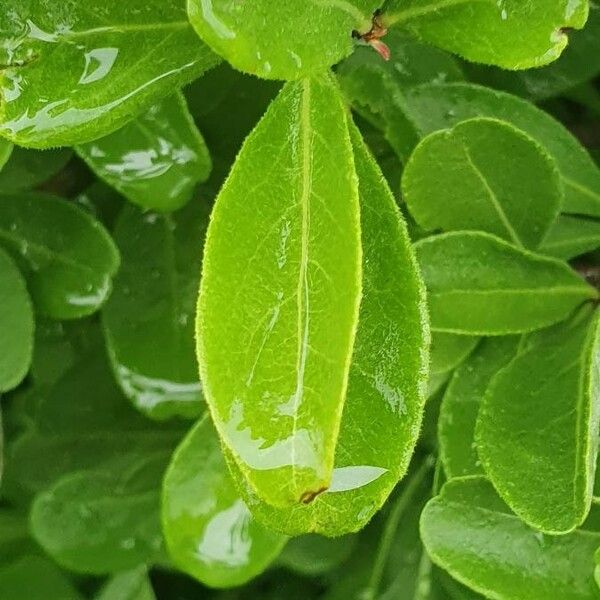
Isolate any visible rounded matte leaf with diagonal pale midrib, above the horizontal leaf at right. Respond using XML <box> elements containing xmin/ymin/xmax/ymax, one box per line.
<box><xmin>402</xmin><ymin>118</ymin><xmax>563</xmax><ymax>249</ymax></box>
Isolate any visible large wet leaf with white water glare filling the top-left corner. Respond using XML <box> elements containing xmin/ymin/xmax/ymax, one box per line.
<box><xmin>0</xmin><ymin>0</ymin><xmax>218</xmax><ymax>148</ymax></box>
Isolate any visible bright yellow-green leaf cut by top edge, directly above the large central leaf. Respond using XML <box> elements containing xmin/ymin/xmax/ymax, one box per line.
<box><xmin>188</xmin><ymin>0</ymin><xmax>380</xmax><ymax>79</ymax></box>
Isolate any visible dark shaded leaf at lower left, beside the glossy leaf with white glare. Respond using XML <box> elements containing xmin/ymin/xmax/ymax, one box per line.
<box><xmin>30</xmin><ymin>454</ymin><xmax>169</xmax><ymax>575</ymax></box>
